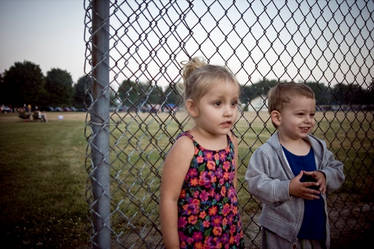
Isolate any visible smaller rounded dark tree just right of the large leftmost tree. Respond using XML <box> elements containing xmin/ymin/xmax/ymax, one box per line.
<box><xmin>45</xmin><ymin>68</ymin><xmax>73</xmax><ymax>106</ymax></box>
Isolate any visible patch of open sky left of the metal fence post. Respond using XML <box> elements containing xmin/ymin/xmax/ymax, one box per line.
<box><xmin>0</xmin><ymin>0</ymin><xmax>85</xmax><ymax>82</ymax></box>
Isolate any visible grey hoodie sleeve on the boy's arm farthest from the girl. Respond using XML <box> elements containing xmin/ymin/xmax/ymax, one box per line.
<box><xmin>319</xmin><ymin>141</ymin><xmax>345</xmax><ymax>192</ymax></box>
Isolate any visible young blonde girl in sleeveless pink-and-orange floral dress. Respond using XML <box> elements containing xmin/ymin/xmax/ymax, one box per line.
<box><xmin>160</xmin><ymin>58</ymin><xmax>244</xmax><ymax>249</ymax></box>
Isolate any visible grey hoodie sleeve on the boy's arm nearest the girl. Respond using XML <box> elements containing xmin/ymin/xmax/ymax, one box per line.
<box><xmin>245</xmin><ymin>144</ymin><xmax>291</xmax><ymax>204</ymax></box>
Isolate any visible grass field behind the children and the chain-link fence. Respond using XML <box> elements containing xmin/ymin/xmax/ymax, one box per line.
<box><xmin>0</xmin><ymin>113</ymin><xmax>374</xmax><ymax>248</ymax></box>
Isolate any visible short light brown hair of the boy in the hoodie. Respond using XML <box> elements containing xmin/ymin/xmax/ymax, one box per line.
<box><xmin>268</xmin><ymin>82</ymin><xmax>315</xmax><ymax>113</ymax></box>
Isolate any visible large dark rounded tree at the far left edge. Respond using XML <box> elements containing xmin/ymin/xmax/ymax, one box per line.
<box><xmin>1</xmin><ymin>61</ymin><xmax>45</xmax><ymax>106</ymax></box>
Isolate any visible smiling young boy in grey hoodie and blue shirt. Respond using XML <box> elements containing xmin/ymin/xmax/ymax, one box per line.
<box><xmin>245</xmin><ymin>83</ymin><xmax>344</xmax><ymax>249</ymax></box>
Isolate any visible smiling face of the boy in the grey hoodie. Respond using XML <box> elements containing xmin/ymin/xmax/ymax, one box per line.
<box><xmin>272</xmin><ymin>95</ymin><xmax>316</xmax><ymax>140</ymax></box>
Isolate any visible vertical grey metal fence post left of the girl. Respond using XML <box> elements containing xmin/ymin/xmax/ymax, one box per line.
<box><xmin>89</xmin><ymin>0</ymin><xmax>111</xmax><ymax>249</ymax></box>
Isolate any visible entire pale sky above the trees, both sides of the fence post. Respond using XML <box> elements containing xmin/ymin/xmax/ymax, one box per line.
<box><xmin>0</xmin><ymin>0</ymin><xmax>374</xmax><ymax>89</ymax></box>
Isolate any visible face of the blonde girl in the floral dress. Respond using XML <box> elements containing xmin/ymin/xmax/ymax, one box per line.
<box><xmin>188</xmin><ymin>81</ymin><xmax>239</xmax><ymax>135</ymax></box>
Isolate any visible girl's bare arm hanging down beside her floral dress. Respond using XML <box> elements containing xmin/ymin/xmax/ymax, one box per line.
<box><xmin>160</xmin><ymin>137</ymin><xmax>194</xmax><ymax>249</ymax></box>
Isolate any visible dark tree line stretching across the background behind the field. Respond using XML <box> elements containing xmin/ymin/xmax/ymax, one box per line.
<box><xmin>0</xmin><ymin>61</ymin><xmax>374</xmax><ymax>109</ymax></box>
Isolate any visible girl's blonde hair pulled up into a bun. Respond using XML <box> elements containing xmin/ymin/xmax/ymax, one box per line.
<box><xmin>182</xmin><ymin>57</ymin><xmax>240</xmax><ymax>101</ymax></box>
